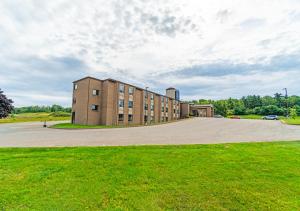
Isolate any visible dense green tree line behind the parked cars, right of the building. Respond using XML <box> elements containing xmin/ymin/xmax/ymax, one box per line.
<box><xmin>192</xmin><ymin>93</ymin><xmax>300</xmax><ymax>116</ymax></box>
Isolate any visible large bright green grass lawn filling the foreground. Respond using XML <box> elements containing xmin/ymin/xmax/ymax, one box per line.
<box><xmin>0</xmin><ymin>142</ymin><xmax>300</xmax><ymax>210</ymax></box>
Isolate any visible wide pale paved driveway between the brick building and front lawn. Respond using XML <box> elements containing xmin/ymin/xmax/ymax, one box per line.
<box><xmin>0</xmin><ymin>118</ymin><xmax>300</xmax><ymax>147</ymax></box>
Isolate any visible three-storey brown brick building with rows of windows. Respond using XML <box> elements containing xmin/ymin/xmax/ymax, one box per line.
<box><xmin>72</xmin><ymin>77</ymin><xmax>180</xmax><ymax>125</ymax></box>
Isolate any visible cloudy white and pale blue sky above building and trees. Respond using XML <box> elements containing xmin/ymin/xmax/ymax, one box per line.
<box><xmin>0</xmin><ymin>0</ymin><xmax>300</xmax><ymax>106</ymax></box>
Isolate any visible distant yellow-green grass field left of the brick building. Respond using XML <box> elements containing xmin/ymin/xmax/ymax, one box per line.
<box><xmin>0</xmin><ymin>113</ymin><xmax>71</xmax><ymax>124</ymax></box>
